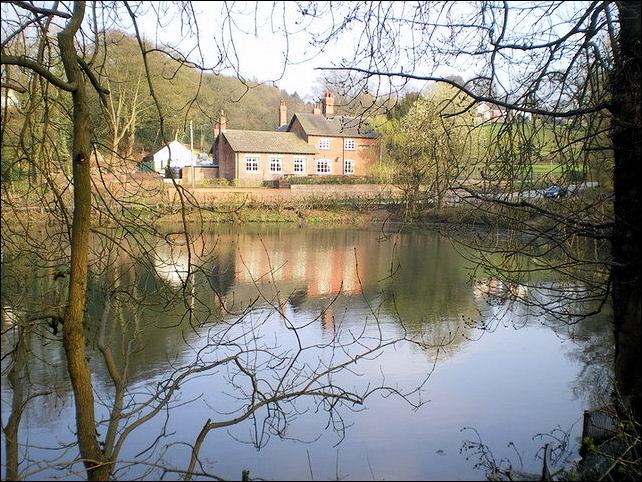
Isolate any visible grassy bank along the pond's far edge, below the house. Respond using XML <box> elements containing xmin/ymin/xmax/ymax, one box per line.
<box><xmin>3</xmin><ymin>179</ymin><xmax>612</xmax><ymax>233</ymax></box>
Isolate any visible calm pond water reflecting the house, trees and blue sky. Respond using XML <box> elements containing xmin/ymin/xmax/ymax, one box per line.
<box><xmin>2</xmin><ymin>225</ymin><xmax>612</xmax><ymax>480</ymax></box>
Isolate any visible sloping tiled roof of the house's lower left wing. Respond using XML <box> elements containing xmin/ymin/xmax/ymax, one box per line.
<box><xmin>223</xmin><ymin>129</ymin><xmax>316</xmax><ymax>154</ymax></box>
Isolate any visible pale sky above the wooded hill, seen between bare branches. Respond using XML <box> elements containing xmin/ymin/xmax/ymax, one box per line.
<box><xmin>3</xmin><ymin>1</ymin><xmax>596</xmax><ymax>102</ymax></box>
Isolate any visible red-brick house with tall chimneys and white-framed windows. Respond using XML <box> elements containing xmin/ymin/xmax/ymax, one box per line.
<box><xmin>210</xmin><ymin>93</ymin><xmax>379</xmax><ymax>185</ymax></box>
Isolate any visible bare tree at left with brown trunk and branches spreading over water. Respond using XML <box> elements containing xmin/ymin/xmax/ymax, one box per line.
<box><xmin>0</xmin><ymin>1</ymin><xmax>438</xmax><ymax>480</ymax></box>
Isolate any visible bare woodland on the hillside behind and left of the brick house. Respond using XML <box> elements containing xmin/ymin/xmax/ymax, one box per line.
<box><xmin>2</xmin><ymin>31</ymin><xmax>312</xmax><ymax>169</ymax></box>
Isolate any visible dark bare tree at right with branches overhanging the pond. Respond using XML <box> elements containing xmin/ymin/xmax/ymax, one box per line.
<box><xmin>278</xmin><ymin>2</ymin><xmax>642</xmax><ymax>420</ymax></box>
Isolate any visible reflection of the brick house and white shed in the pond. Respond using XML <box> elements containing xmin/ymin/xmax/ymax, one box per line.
<box><xmin>148</xmin><ymin>231</ymin><xmax>382</xmax><ymax>329</ymax></box>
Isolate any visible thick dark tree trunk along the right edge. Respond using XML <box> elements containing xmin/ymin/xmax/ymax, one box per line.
<box><xmin>611</xmin><ymin>2</ymin><xmax>642</xmax><ymax>420</ymax></box>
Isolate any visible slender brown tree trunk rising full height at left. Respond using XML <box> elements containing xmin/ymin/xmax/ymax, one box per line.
<box><xmin>58</xmin><ymin>2</ymin><xmax>110</xmax><ymax>480</ymax></box>
